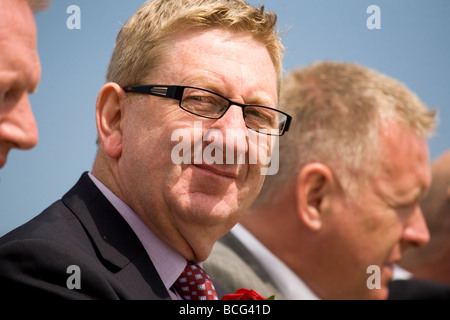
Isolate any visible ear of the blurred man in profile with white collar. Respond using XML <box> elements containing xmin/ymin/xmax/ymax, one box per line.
<box><xmin>296</xmin><ymin>163</ymin><xmax>334</xmax><ymax>231</ymax></box>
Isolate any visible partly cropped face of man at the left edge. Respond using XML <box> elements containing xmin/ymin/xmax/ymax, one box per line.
<box><xmin>0</xmin><ymin>0</ymin><xmax>49</xmax><ymax>169</ymax></box>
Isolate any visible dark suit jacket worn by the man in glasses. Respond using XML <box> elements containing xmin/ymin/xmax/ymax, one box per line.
<box><xmin>0</xmin><ymin>172</ymin><xmax>229</xmax><ymax>300</ymax></box>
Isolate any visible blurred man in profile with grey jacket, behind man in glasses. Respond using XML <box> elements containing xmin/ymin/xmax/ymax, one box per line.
<box><xmin>205</xmin><ymin>61</ymin><xmax>435</xmax><ymax>299</ymax></box>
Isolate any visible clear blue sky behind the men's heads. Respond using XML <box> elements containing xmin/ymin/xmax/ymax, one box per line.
<box><xmin>0</xmin><ymin>0</ymin><xmax>450</xmax><ymax>235</ymax></box>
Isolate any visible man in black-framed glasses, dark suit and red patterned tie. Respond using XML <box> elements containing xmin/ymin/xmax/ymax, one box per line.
<box><xmin>0</xmin><ymin>0</ymin><xmax>290</xmax><ymax>300</ymax></box>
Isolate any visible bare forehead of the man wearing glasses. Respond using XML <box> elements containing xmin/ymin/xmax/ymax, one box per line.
<box><xmin>146</xmin><ymin>29</ymin><xmax>277</xmax><ymax>101</ymax></box>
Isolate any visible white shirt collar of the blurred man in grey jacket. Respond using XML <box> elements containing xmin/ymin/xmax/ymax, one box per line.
<box><xmin>231</xmin><ymin>224</ymin><xmax>319</xmax><ymax>300</ymax></box>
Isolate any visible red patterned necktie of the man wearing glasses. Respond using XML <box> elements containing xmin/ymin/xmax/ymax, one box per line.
<box><xmin>174</xmin><ymin>263</ymin><xmax>218</xmax><ymax>300</ymax></box>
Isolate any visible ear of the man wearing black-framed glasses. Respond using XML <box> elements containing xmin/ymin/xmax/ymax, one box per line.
<box><xmin>95</xmin><ymin>82</ymin><xmax>125</xmax><ymax>158</ymax></box>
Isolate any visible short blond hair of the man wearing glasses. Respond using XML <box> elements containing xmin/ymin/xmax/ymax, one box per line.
<box><xmin>106</xmin><ymin>0</ymin><xmax>284</xmax><ymax>91</ymax></box>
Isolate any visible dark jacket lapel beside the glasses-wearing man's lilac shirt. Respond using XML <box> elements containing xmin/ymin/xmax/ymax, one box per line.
<box><xmin>62</xmin><ymin>172</ymin><xmax>170</xmax><ymax>299</ymax></box>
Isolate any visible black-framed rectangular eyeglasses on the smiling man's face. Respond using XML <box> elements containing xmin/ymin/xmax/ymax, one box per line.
<box><xmin>123</xmin><ymin>85</ymin><xmax>292</xmax><ymax>136</ymax></box>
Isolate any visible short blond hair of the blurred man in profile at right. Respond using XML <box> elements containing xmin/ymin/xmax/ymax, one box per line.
<box><xmin>257</xmin><ymin>61</ymin><xmax>435</xmax><ymax>203</ymax></box>
